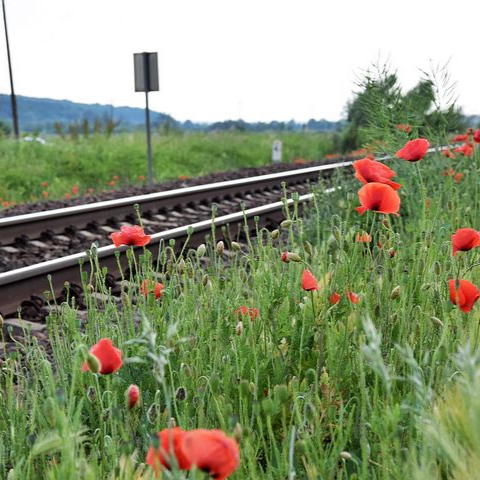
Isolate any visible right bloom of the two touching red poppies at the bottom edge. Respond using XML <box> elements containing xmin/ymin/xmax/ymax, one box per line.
<box><xmin>182</xmin><ymin>429</ymin><xmax>240</xmax><ymax>480</ymax></box>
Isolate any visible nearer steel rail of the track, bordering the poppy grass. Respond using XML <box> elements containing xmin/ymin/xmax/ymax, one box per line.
<box><xmin>0</xmin><ymin>193</ymin><xmax>326</xmax><ymax>316</ymax></box>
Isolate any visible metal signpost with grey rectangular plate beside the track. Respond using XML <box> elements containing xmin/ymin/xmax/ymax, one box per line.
<box><xmin>133</xmin><ymin>52</ymin><xmax>160</xmax><ymax>185</ymax></box>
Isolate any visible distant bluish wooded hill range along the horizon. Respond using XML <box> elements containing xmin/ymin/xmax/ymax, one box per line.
<box><xmin>0</xmin><ymin>94</ymin><xmax>344</xmax><ymax>133</ymax></box>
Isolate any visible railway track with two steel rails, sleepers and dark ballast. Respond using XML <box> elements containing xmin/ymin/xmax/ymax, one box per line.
<box><xmin>0</xmin><ymin>148</ymin><xmax>448</xmax><ymax>357</ymax></box>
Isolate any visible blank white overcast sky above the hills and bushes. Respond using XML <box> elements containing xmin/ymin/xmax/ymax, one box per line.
<box><xmin>0</xmin><ymin>0</ymin><xmax>480</xmax><ymax>122</ymax></box>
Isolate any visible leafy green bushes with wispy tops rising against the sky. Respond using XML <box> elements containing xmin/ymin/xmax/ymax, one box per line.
<box><xmin>342</xmin><ymin>64</ymin><xmax>465</xmax><ymax>152</ymax></box>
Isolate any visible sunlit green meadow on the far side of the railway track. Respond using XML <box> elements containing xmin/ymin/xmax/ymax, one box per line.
<box><xmin>0</xmin><ymin>132</ymin><xmax>332</xmax><ymax>205</ymax></box>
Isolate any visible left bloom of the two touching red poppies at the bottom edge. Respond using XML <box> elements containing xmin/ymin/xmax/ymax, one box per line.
<box><xmin>145</xmin><ymin>427</ymin><xmax>192</xmax><ymax>475</ymax></box>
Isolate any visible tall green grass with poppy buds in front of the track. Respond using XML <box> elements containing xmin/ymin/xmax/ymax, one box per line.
<box><xmin>0</xmin><ymin>134</ymin><xmax>480</xmax><ymax>480</ymax></box>
